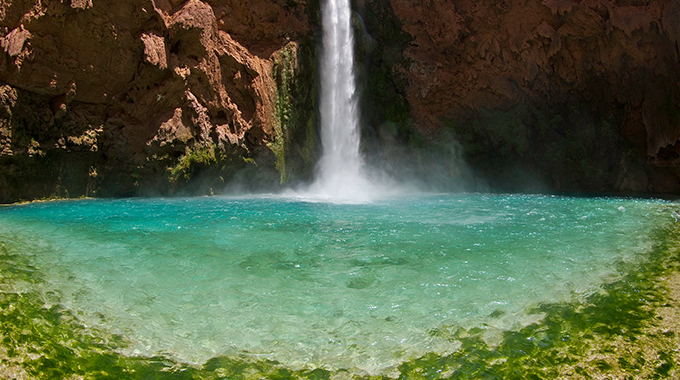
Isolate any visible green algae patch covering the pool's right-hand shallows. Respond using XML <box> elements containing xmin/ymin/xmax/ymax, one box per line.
<box><xmin>390</xmin><ymin>217</ymin><xmax>680</xmax><ymax>379</ymax></box>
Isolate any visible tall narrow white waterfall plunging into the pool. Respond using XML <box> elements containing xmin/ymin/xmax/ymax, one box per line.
<box><xmin>312</xmin><ymin>0</ymin><xmax>371</xmax><ymax>200</ymax></box>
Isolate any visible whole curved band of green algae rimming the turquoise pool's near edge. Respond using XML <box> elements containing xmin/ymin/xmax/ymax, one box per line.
<box><xmin>0</xmin><ymin>208</ymin><xmax>680</xmax><ymax>380</ymax></box>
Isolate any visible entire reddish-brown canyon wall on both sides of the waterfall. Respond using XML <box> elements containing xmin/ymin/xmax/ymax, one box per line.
<box><xmin>0</xmin><ymin>0</ymin><xmax>680</xmax><ymax>202</ymax></box>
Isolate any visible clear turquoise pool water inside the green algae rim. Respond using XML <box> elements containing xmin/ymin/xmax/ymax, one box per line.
<box><xmin>0</xmin><ymin>194</ymin><xmax>673</xmax><ymax>374</ymax></box>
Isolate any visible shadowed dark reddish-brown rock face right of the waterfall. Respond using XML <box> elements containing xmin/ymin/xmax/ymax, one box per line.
<box><xmin>358</xmin><ymin>0</ymin><xmax>680</xmax><ymax>193</ymax></box>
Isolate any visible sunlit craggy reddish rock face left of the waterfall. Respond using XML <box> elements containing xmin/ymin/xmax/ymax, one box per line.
<box><xmin>0</xmin><ymin>0</ymin><xmax>314</xmax><ymax>202</ymax></box>
